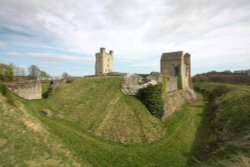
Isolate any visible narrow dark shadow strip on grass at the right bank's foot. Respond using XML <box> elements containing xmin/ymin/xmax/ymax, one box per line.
<box><xmin>186</xmin><ymin>100</ymin><xmax>214</xmax><ymax>167</ymax></box>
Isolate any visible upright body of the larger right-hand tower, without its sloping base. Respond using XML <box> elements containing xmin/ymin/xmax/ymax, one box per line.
<box><xmin>161</xmin><ymin>51</ymin><xmax>191</xmax><ymax>92</ymax></box>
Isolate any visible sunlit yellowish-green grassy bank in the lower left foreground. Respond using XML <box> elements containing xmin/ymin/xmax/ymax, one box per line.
<box><xmin>0</xmin><ymin>93</ymin><xmax>87</xmax><ymax>166</ymax></box>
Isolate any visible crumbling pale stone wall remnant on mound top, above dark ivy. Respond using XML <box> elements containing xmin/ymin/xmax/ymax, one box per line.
<box><xmin>122</xmin><ymin>73</ymin><xmax>158</xmax><ymax>95</ymax></box>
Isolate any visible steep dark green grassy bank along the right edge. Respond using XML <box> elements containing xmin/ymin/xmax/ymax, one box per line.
<box><xmin>192</xmin><ymin>83</ymin><xmax>250</xmax><ymax>166</ymax></box>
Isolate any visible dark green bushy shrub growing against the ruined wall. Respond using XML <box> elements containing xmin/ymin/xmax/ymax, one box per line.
<box><xmin>137</xmin><ymin>84</ymin><xmax>164</xmax><ymax>118</ymax></box>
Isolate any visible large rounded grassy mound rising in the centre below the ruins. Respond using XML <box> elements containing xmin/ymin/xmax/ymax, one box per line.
<box><xmin>48</xmin><ymin>77</ymin><xmax>164</xmax><ymax>143</ymax></box>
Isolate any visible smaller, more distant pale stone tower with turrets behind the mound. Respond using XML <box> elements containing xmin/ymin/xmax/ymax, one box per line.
<box><xmin>95</xmin><ymin>48</ymin><xmax>113</xmax><ymax>75</ymax></box>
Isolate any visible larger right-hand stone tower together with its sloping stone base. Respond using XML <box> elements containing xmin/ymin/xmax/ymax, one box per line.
<box><xmin>161</xmin><ymin>51</ymin><xmax>196</xmax><ymax>119</ymax></box>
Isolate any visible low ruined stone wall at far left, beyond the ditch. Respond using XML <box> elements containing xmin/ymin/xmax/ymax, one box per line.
<box><xmin>8</xmin><ymin>80</ymin><xmax>42</xmax><ymax>100</ymax></box>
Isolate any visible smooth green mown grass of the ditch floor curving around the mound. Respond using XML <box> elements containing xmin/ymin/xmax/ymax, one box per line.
<box><xmin>25</xmin><ymin>92</ymin><xmax>204</xmax><ymax>167</ymax></box>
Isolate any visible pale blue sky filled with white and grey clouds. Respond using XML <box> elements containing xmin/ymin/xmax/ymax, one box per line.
<box><xmin>0</xmin><ymin>0</ymin><xmax>250</xmax><ymax>76</ymax></box>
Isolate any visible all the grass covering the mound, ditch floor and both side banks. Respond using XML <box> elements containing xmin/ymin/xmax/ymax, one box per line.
<box><xmin>0</xmin><ymin>77</ymin><xmax>250</xmax><ymax>167</ymax></box>
